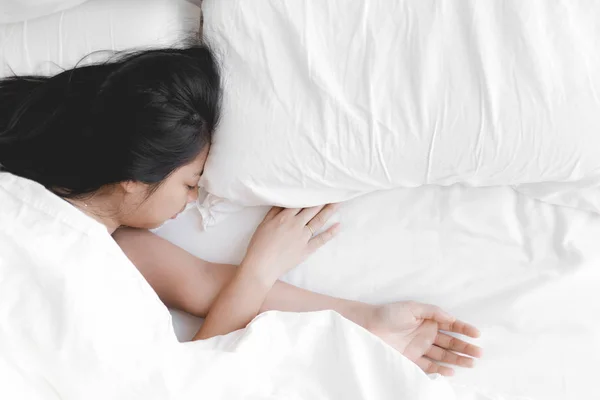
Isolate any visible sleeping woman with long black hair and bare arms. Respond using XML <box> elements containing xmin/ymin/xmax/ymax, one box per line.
<box><xmin>0</xmin><ymin>45</ymin><xmax>481</xmax><ymax>375</ymax></box>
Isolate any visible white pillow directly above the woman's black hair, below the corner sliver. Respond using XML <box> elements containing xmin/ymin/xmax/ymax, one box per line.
<box><xmin>0</xmin><ymin>0</ymin><xmax>200</xmax><ymax>76</ymax></box>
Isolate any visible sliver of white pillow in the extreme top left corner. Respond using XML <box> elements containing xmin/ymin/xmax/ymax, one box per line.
<box><xmin>0</xmin><ymin>0</ymin><xmax>86</xmax><ymax>24</ymax></box>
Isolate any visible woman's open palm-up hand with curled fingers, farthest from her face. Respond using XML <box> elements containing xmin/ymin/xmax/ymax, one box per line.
<box><xmin>362</xmin><ymin>301</ymin><xmax>482</xmax><ymax>376</ymax></box>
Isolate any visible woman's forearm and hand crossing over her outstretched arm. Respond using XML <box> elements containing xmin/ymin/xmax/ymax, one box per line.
<box><xmin>194</xmin><ymin>205</ymin><xmax>338</xmax><ymax>340</ymax></box>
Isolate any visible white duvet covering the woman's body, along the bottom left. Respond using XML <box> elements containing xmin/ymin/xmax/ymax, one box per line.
<box><xmin>0</xmin><ymin>173</ymin><xmax>510</xmax><ymax>400</ymax></box>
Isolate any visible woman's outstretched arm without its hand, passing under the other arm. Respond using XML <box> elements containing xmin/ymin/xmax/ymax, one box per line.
<box><xmin>113</xmin><ymin>220</ymin><xmax>360</xmax><ymax>324</ymax></box>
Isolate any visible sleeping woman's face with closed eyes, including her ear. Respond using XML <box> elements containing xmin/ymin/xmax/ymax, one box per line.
<box><xmin>122</xmin><ymin>146</ymin><xmax>209</xmax><ymax>229</ymax></box>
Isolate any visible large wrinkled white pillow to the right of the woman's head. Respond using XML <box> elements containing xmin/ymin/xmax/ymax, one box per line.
<box><xmin>201</xmin><ymin>0</ymin><xmax>600</xmax><ymax>207</ymax></box>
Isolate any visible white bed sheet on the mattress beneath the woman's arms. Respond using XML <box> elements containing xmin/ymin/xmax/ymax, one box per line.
<box><xmin>158</xmin><ymin>186</ymin><xmax>600</xmax><ymax>400</ymax></box>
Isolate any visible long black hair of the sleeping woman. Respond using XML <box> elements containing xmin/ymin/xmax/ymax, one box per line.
<box><xmin>0</xmin><ymin>44</ymin><xmax>221</xmax><ymax>198</ymax></box>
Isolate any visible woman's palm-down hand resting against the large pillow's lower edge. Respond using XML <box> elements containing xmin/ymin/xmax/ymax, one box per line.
<box><xmin>241</xmin><ymin>204</ymin><xmax>339</xmax><ymax>284</ymax></box>
